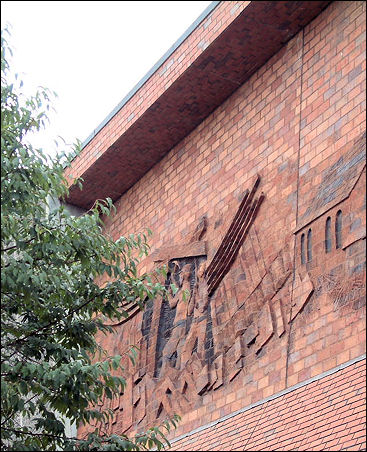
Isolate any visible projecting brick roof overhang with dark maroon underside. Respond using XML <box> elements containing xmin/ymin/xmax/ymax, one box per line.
<box><xmin>66</xmin><ymin>1</ymin><xmax>330</xmax><ymax>209</ymax></box>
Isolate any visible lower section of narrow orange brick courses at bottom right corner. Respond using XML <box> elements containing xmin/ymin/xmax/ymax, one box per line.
<box><xmin>170</xmin><ymin>360</ymin><xmax>366</xmax><ymax>451</ymax></box>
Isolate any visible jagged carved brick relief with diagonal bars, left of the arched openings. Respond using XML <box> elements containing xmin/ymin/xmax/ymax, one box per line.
<box><xmin>112</xmin><ymin>176</ymin><xmax>290</xmax><ymax>425</ymax></box>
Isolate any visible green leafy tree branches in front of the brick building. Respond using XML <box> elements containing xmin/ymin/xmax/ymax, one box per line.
<box><xmin>1</xmin><ymin>32</ymin><xmax>177</xmax><ymax>450</ymax></box>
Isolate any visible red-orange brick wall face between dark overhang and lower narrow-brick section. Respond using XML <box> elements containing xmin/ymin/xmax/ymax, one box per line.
<box><xmin>76</xmin><ymin>1</ymin><xmax>366</xmax><ymax>444</ymax></box>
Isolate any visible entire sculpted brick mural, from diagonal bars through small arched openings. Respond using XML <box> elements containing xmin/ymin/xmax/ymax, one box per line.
<box><xmin>91</xmin><ymin>144</ymin><xmax>365</xmax><ymax>431</ymax></box>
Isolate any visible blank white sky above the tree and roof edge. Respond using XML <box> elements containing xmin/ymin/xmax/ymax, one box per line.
<box><xmin>1</xmin><ymin>1</ymin><xmax>211</xmax><ymax>159</ymax></box>
